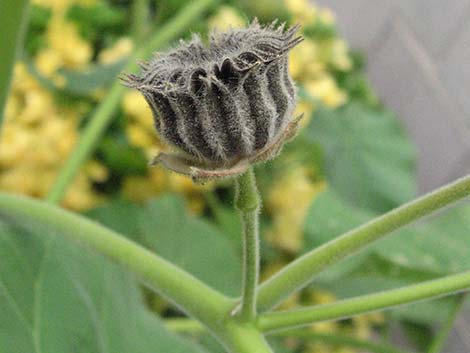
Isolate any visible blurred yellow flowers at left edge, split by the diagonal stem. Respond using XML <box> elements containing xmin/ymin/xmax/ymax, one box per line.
<box><xmin>0</xmin><ymin>63</ymin><xmax>106</xmax><ymax>210</ymax></box>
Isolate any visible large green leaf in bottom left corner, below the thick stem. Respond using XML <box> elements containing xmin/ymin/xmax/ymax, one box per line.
<box><xmin>0</xmin><ymin>223</ymin><xmax>206</xmax><ymax>353</ymax></box>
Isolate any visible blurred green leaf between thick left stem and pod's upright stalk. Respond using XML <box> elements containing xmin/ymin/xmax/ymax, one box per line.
<box><xmin>87</xmin><ymin>195</ymin><xmax>241</xmax><ymax>296</ymax></box>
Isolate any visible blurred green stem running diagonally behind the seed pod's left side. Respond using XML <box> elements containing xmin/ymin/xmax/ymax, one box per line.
<box><xmin>47</xmin><ymin>0</ymin><xmax>216</xmax><ymax>203</ymax></box>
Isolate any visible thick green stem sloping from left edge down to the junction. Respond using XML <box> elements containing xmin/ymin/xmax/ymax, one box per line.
<box><xmin>0</xmin><ymin>194</ymin><xmax>233</xmax><ymax>332</ymax></box>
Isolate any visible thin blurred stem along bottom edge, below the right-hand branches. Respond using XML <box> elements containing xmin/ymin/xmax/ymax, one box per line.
<box><xmin>275</xmin><ymin>330</ymin><xmax>410</xmax><ymax>353</ymax></box>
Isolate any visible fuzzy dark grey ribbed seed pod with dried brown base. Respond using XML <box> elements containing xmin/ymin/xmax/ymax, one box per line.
<box><xmin>123</xmin><ymin>20</ymin><xmax>302</xmax><ymax>179</ymax></box>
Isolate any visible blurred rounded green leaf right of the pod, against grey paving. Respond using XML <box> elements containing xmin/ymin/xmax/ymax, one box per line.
<box><xmin>306</xmin><ymin>103</ymin><xmax>415</xmax><ymax>212</ymax></box>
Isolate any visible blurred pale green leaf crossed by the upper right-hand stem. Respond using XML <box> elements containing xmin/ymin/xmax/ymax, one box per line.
<box><xmin>305</xmin><ymin>189</ymin><xmax>470</xmax><ymax>275</ymax></box>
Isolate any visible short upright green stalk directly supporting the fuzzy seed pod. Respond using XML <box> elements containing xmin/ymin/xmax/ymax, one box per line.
<box><xmin>235</xmin><ymin>168</ymin><xmax>260</xmax><ymax>321</ymax></box>
